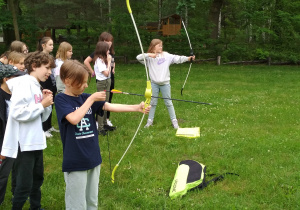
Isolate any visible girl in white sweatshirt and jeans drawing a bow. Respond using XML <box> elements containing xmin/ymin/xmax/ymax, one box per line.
<box><xmin>136</xmin><ymin>39</ymin><xmax>195</xmax><ymax>129</ymax></box>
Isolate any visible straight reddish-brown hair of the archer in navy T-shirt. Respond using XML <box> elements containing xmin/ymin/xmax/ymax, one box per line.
<box><xmin>60</xmin><ymin>60</ymin><xmax>91</xmax><ymax>87</ymax></box>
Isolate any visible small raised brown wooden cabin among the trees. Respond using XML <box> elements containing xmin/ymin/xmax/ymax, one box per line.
<box><xmin>141</xmin><ymin>14</ymin><xmax>182</xmax><ymax>36</ymax></box>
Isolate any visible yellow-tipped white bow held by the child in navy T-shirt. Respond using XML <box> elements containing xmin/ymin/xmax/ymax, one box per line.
<box><xmin>111</xmin><ymin>0</ymin><xmax>152</xmax><ymax>183</ymax></box>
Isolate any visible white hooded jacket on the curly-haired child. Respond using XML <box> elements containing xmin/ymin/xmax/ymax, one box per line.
<box><xmin>1</xmin><ymin>75</ymin><xmax>52</xmax><ymax>158</ymax></box>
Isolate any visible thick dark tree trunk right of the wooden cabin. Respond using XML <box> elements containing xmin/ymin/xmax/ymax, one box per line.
<box><xmin>209</xmin><ymin>0</ymin><xmax>224</xmax><ymax>39</ymax></box>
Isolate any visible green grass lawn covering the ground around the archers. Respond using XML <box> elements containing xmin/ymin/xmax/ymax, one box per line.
<box><xmin>3</xmin><ymin>64</ymin><xmax>300</xmax><ymax>209</ymax></box>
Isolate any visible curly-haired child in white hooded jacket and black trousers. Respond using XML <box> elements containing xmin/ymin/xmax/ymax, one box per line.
<box><xmin>1</xmin><ymin>52</ymin><xmax>55</xmax><ymax>209</ymax></box>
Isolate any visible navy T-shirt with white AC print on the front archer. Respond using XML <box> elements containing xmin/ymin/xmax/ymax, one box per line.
<box><xmin>55</xmin><ymin>93</ymin><xmax>105</xmax><ymax>172</ymax></box>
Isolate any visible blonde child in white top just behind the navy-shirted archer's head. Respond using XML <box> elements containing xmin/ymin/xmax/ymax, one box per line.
<box><xmin>52</xmin><ymin>42</ymin><xmax>73</xmax><ymax>93</ymax></box>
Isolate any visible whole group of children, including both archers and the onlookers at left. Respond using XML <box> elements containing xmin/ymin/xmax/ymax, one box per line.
<box><xmin>0</xmin><ymin>32</ymin><xmax>195</xmax><ymax>209</ymax></box>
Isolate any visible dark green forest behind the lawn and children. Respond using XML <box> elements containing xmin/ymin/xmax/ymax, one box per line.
<box><xmin>0</xmin><ymin>0</ymin><xmax>300</xmax><ymax>64</ymax></box>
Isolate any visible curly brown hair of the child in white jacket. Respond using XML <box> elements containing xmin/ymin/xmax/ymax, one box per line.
<box><xmin>24</xmin><ymin>51</ymin><xmax>55</xmax><ymax>74</ymax></box>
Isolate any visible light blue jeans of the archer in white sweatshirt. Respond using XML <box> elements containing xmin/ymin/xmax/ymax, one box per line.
<box><xmin>148</xmin><ymin>82</ymin><xmax>176</xmax><ymax>121</ymax></box>
